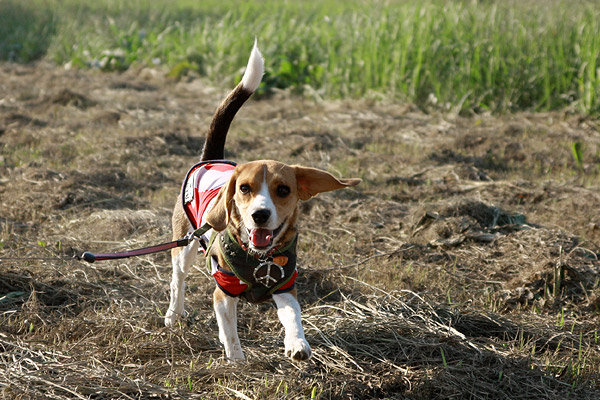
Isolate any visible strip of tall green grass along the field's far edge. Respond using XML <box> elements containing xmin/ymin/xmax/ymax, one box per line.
<box><xmin>0</xmin><ymin>0</ymin><xmax>600</xmax><ymax>113</ymax></box>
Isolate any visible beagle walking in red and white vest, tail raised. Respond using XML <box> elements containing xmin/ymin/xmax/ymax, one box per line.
<box><xmin>165</xmin><ymin>42</ymin><xmax>361</xmax><ymax>361</ymax></box>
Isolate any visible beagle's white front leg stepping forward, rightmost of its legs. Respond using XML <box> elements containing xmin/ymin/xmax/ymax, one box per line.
<box><xmin>273</xmin><ymin>290</ymin><xmax>312</xmax><ymax>361</ymax></box>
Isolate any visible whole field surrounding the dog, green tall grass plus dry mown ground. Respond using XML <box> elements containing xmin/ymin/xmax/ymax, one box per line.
<box><xmin>0</xmin><ymin>0</ymin><xmax>600</xmax><ymax>399</ymax></box>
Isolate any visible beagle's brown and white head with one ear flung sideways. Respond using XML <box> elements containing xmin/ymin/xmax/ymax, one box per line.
<box><xmin>207</xmin><ymin>161</ymin><xmax>361</xmax><ymax>252</ymax></box>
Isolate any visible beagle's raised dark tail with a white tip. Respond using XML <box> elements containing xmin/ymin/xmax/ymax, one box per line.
<box><xmin>201</xmin><ymin>40</ymin><xmax>265</xmax><ymax>161</ymax></box>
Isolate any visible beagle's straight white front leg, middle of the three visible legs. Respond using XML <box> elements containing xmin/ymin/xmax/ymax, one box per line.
<box><xmin>213</xmin><ymin>288</ymin><xmax>245</xmax><ymax>361</ymax></box>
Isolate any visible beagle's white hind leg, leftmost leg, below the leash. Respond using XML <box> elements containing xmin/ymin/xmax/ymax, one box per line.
<box><xmin>165</xmin><ymin>240</ymin><xmax>198</xmax><ymax>326</ymax></box>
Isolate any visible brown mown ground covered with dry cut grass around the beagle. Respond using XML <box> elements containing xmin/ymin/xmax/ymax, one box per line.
<box><xmin>0</xmin><ymin>63</ymin><xmax>600</xmax><ymax>399</ymax></box>
